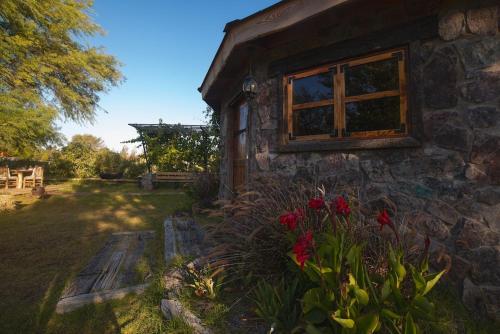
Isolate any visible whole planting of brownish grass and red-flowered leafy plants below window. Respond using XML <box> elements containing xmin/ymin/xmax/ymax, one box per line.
<box><xmin>207</xmin><ymin>177</ymin><xmax>446</xmax><ymax>334</ymax></box>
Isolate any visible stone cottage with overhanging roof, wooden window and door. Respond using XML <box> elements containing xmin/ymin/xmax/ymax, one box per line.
<box><xmin>199</xmin><ymin>0</ymin><xmax>500</xmax><ymax>319</ymax></box>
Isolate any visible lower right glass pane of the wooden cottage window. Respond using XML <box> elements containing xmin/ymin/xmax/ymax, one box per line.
<box><xmin>345</xmin><ymin>96</ymin><xmax>401</xmax><ymax>132</ymax></box>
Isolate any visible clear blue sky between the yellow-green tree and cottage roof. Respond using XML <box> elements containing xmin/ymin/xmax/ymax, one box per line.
<box><xmin>60</xmin><ymin>0</ymin><xmax>278</xmax><ymax>150</ymax></box>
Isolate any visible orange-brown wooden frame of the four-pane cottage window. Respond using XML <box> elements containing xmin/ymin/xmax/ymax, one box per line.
<box><xmin>283</xmin><ymin>48</ymin><xmax>409</xmax><ymax>143</ymax></box>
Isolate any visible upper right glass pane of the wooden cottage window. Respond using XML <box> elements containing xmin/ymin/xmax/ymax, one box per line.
<box><xmin>345</xmin><ymin>58</ymin><xmax>399</xmax><ymax>96</ymax></box>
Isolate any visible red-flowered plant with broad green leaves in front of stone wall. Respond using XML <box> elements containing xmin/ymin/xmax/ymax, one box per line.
<box><xmin>257</xmin><ymin>189</ymin><xmax>446</xmax><ymax>334</ymax></box>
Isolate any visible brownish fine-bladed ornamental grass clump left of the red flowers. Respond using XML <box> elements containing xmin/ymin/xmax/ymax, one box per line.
<box><xmin>207</xmin><ymin>177</ymin><xmax>314</xmax><ymax>280</ymax></box>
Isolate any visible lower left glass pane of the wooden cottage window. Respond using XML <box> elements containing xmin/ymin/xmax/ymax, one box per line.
<box><xmin>293</xmin><ymin>106</ymin><xmax>333</xmax><ymax>136</ymax></box>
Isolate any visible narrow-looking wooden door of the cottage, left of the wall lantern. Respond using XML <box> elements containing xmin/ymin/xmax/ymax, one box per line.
<box><xmin>233</xmin><ymin>102</ymin><xmax>248</xmax><ymax>190</ymax></box>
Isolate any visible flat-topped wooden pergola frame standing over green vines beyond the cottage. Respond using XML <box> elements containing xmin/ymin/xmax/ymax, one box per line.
<box><xmin>128</xmin><ymin>122</ymin><xmax>209</xmax><ymax>173</ymax></box>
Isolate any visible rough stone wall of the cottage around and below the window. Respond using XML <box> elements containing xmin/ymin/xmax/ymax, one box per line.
<box><xmin>221</xmin><ymin>6</ymin><xmax>500</xmax><ymax>319</ymax></box>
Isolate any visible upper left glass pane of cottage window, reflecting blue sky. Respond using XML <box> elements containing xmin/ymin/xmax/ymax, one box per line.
<box><xmin>293</xmin><ymin>72</ymin><xmax>333</xmax><ymax>104</ymax></box>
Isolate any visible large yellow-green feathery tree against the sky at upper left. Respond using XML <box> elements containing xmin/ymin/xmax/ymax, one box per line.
<box><xmin>0</xmin><ymin>0</ymin><xmax>122</xmax><ymax>152</ymax></box>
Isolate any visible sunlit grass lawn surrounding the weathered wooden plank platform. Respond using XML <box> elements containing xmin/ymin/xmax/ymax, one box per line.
<box><xmin>0</xmin><ymin>182</ymin><xmax>191</xmax><ymax>333</ymax></box>
